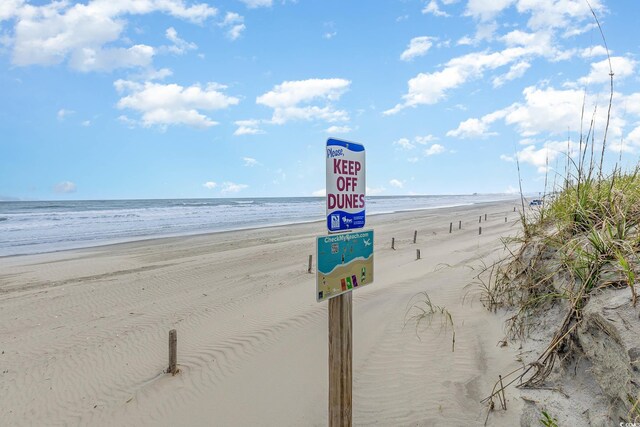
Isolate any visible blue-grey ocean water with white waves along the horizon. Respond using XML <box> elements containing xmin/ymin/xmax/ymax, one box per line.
<box><xmin>0</xmin><ymin>194</ymin><xmax>514</xmax><ymax>256</ymax></box>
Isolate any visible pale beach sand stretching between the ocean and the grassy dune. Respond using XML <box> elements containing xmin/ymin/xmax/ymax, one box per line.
<box><xmin>0</xmin><ymin>202</ymin><xmax>522</xmax><ymax>426</ymax></box>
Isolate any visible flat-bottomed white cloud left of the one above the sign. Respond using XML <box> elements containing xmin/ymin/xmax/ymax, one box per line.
<box><xmin>114</xmin><ymin>80</ymin><xmax>239</xmax><ymax>128</ymax></box>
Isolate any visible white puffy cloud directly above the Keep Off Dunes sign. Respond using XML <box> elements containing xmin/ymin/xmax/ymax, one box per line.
<box><xmin>256</xmin><ymin>79</ymin><xmax>351</xmax><ymax>124</ymax></box>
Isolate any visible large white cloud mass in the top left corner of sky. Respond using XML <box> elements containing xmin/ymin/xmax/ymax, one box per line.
<box><xmin>4</xmin><ymin>0</ymin><xmax>217</xmax><ymax>71</ymax></box>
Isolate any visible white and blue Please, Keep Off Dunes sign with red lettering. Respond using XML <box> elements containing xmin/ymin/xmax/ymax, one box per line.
<box><xmin>326</xmin><ymin>138</ymin><xmax>367</xmax><ymax>231</ymax></box>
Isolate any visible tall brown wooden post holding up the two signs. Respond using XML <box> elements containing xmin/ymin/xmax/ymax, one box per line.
<box><xmin>329</xmin><ymin>292</ymin><xmax>353</xmax><ymax>427</ymax></box>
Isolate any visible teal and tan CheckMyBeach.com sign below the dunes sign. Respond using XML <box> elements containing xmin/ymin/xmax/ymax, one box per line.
<box><xmin>316</xmin><ymin>230</ymin><xmax>373</xmax><ymax>302</ymax></box>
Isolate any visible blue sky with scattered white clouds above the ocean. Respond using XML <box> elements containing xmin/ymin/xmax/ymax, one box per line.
<box><xmin>0</xmin><ymin>0</ymin><xmax>640</xmax><ymax>200</ymax></box>
